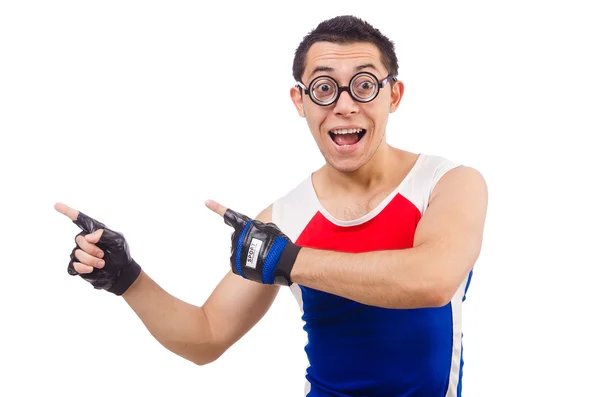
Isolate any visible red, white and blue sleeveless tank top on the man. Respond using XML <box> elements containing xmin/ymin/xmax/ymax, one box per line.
<box><xmin>272</xmin><ymin>154</ymin><xmax>472</xmax><ymax>397</ymax></box>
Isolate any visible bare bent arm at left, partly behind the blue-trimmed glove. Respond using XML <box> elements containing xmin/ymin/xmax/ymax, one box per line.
<box><xmin>123</xmin><ymin>207</ymin><xmax>279</xmax><ymax>365</ymax></box>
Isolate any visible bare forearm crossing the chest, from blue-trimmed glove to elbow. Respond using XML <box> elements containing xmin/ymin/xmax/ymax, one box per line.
<box><xmin>291</xmin><ymin>248</ymin><xmax>448</xmax><ymax>308</ymax></box>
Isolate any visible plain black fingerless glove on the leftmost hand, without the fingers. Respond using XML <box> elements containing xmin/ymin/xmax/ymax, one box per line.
<box><xmin>67</xmin><ymin>212</ymin><xmax>142</xmax><ymax>295</ymax></box>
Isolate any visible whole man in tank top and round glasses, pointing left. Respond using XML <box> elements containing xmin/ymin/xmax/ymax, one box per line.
<box><xmin>56</xmin><ymin>16</ymin><xmax>487</xmax><ymax>397</ymax></box>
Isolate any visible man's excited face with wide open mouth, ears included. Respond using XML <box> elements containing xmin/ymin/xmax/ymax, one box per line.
<box><xmin>290</xmin><ymin>42</ymin><xmax>403</xmax><ymax>172</ymax></box>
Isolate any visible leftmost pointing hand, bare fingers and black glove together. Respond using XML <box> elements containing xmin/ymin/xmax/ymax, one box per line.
<box><xmin>54</xmin><ymin>203</ymin><xmax>141</xmax><ymax>295</ymax></box>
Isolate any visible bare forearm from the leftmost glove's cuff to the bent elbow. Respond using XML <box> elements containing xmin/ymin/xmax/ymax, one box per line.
<box><xmin>123</xmin><ymin>271</ymin><xmax>220</xmax><ymax>364</ymax></box>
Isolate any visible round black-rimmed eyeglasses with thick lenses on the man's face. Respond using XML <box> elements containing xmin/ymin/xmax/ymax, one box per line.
<box><xmin>296</xmin><ymin>72</ymin><xmax>396</xmax><ymax>106</ymax></box>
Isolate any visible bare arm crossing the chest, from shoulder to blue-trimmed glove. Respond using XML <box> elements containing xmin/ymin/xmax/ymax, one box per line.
<box><xmin>291</xmin><ymin>167</ymin><xmax>487</xmax><ymax>308</ymax></box>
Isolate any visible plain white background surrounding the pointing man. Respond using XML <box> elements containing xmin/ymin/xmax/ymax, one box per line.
<box><xmin>0</xmin><ymin>1</ymin><xmax>600</xmax><ymax>396</ymax></box>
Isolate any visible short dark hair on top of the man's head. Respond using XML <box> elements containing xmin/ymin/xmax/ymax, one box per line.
<box><xmin>292</xmin><ymin>15</ymin><xmax>398</xmax><ymax>81</ymax></box>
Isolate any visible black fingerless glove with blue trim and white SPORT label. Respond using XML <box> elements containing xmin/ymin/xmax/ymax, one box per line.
<box><xmin>223</xmin><ymin>209</ymin><xmax>300</xmax><ymax>286</ymax></box>
